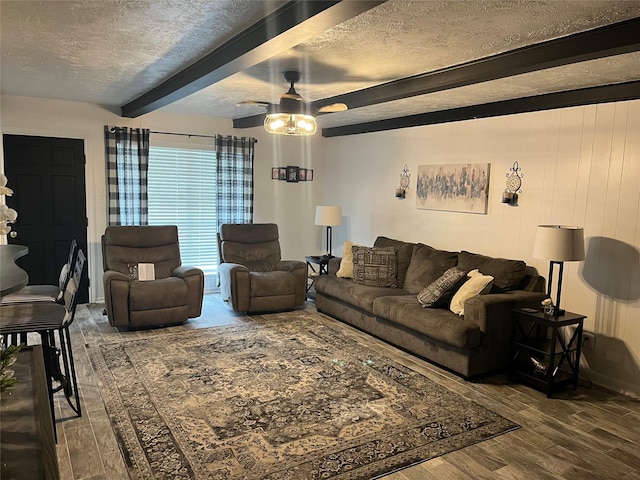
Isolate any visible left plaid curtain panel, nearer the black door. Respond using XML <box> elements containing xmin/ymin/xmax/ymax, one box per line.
<box><xmin>104</xmin><ymin>125</ymin><xmax>149</xmax><ymax>225</ymax></box>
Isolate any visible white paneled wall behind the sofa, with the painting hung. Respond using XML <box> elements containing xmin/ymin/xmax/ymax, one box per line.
<box><xmin>324</xmin><ymin>101</ymin><xmax>640</xmax><ymax>397</ymax></box>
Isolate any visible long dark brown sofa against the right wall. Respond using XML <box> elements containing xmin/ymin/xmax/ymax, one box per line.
<box><xmin>314</xmin><ymin>237</ymin><xmax>545</xmax><ymax>377</ymax></box>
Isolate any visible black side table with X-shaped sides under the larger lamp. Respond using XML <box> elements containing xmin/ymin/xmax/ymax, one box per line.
<box><xmin>509</xmin><ymin>308</ymin><xmax>586</xmax><ymax>397</ymax></box>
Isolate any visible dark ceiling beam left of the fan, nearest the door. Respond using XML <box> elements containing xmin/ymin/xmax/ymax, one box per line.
<box><xmin>121</xmin><ymin>0</ymin><xmax>386</xmax><ymax>118</ymax></box>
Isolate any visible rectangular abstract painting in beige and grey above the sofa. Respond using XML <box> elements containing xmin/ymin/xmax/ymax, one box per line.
<box><xmin>416</xmin><ymin>163</ymin><xmax>491</xmax><ymax>215</ymax></box>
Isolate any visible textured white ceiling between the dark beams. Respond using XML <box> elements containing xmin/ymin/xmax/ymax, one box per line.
<box><xmin>0</xmin><ymin>0</ymin><xmax>640</xmax><ymax>135</ymax></box>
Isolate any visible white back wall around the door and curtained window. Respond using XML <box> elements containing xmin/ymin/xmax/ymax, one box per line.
<box><xmin>0</xmin><ymin>95</ymin><xmax>324</xmax><ymax>302</ymax></box>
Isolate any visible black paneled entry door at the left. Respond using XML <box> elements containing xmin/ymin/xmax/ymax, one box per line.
<box><xmin>3</xmin><ymin>135</ymin><xmax>89</xmax><ymax>303</ymax></box>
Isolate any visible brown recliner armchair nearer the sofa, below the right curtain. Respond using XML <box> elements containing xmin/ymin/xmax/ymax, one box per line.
<box><xmin>218</xmin><ymin>223</ymin><xmax>307</xmax><ymax>312</ymax></box>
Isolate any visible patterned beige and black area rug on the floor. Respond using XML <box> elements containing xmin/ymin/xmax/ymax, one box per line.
<box><xmin>89</xmin><ymin>312</ymin><xmax>518</xmax><ymax>480</ymax></box>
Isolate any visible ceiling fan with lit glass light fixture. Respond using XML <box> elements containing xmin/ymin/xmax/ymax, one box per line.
<box><xmin>238</xmin><ymin>70</ymin><xmax>348</xmax><ymax>135</ymax></box>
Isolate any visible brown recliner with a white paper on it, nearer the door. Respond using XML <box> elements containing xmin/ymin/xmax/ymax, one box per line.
<box><xmin>102</xmin><ymin>225</ymin><xmax>204</xmax><ymax>328</ymax></box>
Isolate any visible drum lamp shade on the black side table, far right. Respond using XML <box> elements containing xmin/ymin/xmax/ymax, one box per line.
<box><xmin>533</xmin><ymin>225</ymin><xmax>584</xmax><ymax>262</ymax></box>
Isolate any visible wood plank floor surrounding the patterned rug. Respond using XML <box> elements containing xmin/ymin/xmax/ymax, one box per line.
<box><xmin>50</xmin><ymin>295</ymin><xmax>640</xmax><ymax>480</ymax></box>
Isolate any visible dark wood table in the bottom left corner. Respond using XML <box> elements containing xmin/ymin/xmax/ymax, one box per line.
<box><xmin>0</xmin><ymin>345</ymin><xmax>60</xmax><ymax>480</ymax></box>
